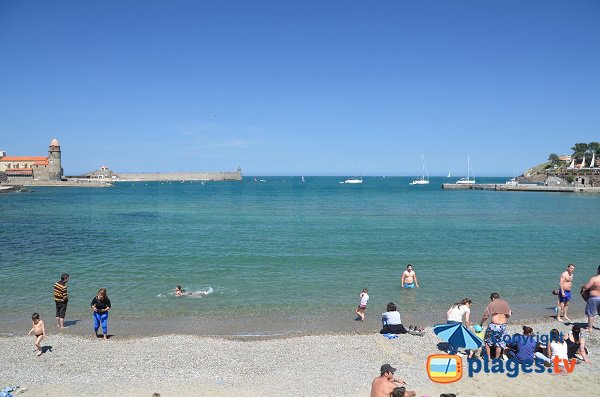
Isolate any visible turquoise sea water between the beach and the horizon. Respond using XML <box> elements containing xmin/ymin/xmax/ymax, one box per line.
<box><xmin>0</xmin><ymin>176</ymin><xmax>600</xmax><ymax>334</ymax></box>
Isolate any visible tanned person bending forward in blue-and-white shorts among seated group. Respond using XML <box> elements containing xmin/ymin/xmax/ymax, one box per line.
<box><xmin>479</xmin><ymin>292</ymin><xmax>512</xmax><ymax>358</ymax></box>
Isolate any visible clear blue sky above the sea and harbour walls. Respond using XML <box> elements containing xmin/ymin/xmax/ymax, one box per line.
<box><xmin>0</xmin><ymin>0</ymin><xmax>600</xmax><ymax>176</ymax></box>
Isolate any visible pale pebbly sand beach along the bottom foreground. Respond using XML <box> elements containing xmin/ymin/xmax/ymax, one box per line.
<box><xmin>0</xmin><ymin>318</ymin><xmax>600</xmax><ymax>397</ymax></box>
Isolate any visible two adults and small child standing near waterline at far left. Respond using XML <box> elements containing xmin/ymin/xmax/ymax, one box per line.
<box><xmin>27</xmin><ymin>273</ymin><xmax>111</xmax><ymax>356</ymax></box>
